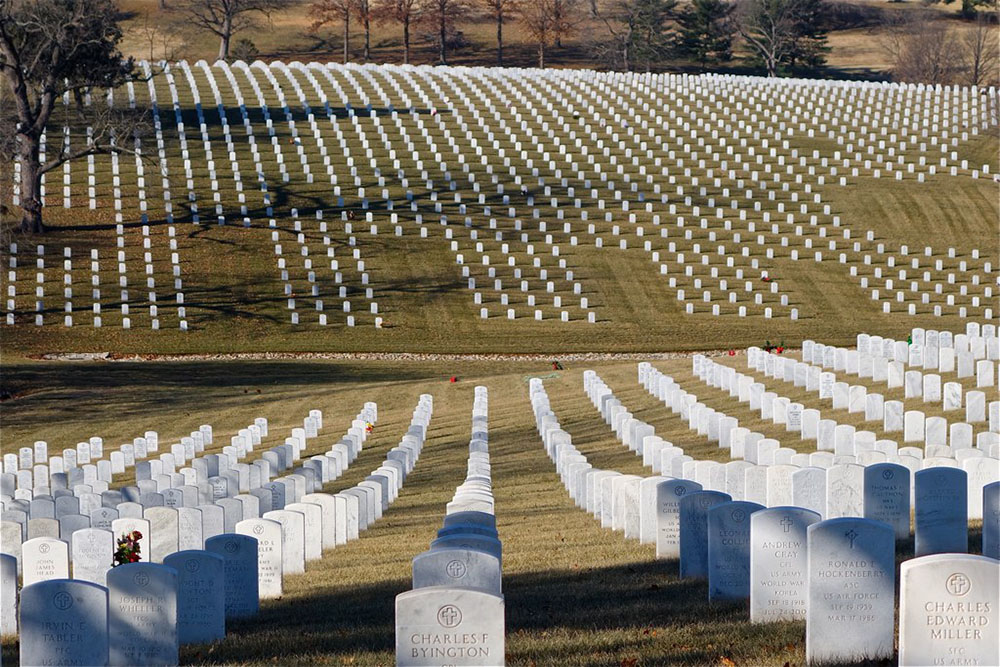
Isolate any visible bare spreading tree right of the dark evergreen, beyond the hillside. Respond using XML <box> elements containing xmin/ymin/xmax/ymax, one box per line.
<box><xmin>733</xmin><ymin>0</ymin><xmax>826</xmax><ymax>76</ymax></box>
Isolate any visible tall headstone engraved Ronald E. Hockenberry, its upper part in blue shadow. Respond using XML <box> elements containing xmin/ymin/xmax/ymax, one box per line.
<box><xmin>806</xmin><ymin>517</ymin><xmax>896</xmax><ymax>663</ymax></box>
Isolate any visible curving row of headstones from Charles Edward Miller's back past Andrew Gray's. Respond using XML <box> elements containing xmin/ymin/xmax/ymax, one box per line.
<box><xmin>532</xmin><ymin>380</ymin><xmax>1000</xmax><ymax>665</ymax></box>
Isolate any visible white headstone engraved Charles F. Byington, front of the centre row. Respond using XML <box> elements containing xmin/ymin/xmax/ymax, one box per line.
<box><xmin>396</xmin><ymin>586</ymin><xmax>505</xmax><ymax>667</ymax></box>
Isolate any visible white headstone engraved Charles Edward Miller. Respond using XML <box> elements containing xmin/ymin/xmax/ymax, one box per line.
<box><xmin>899</xmin><ymin>554</ymin><xmax>1000</xmax><ymax>667</ymax></box>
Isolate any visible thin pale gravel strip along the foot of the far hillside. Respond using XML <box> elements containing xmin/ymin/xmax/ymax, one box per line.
<box><xmin>32</xmin><ymin>350</ymin><xmax>764</xmax><ymax>362</ymax></box>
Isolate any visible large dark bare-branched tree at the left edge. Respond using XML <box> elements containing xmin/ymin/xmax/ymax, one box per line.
<box><xmin>0</xmin><ymin>0</ymin><xmax>143</xmax><ymax>233</ymax></box>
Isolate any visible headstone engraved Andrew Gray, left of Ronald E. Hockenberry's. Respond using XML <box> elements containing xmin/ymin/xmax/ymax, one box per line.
<box><xmin>750</xmin><ymin>507</ymin><xmax>821</xmax><ymax>623</ymax></box>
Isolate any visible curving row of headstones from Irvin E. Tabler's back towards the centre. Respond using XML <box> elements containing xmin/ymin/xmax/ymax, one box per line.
<box><xmin>4</xmin><ymin>395</ymin><xmax>432</xmax><ymax>665</ymax></box>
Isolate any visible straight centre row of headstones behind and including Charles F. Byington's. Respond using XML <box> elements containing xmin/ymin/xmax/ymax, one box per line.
<box><xmin>395</xmin><ymin>386</ymin><xmax>505</xmax><ymax>665</ymax></box>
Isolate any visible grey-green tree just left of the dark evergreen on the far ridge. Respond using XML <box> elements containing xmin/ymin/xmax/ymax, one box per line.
<box><xmin>591</xmin><ymin>0</ymin><xmax>677</xmax><ymax>71</ymax></box>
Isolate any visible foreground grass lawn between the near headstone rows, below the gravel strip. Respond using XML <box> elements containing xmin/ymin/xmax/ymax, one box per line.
<box><xmin>3</xmin><ymin>355</ymin><xmax>981</xmax><ymax>666</ymax></box>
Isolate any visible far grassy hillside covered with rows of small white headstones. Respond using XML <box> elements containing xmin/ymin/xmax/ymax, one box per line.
<box><xmin>2</xmin><ymin>66</ymin><xmax>1000</xmax><ymax>354</ymax></box>
